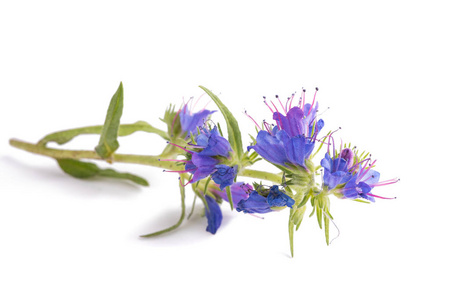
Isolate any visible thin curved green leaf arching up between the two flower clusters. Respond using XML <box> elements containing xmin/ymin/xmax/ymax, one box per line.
<box><xmin>200</xmin><ymin>85</ymin><xmax>243</xmax><ymax>160</ymax></box>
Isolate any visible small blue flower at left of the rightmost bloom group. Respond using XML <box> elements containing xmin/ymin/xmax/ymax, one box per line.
<box><xmin>321</xmin><ymin>152</ymin><xmax>352</xmax><ymax>190</ymax></box>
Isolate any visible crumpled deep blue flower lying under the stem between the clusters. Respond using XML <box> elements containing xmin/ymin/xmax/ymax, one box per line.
<box><xmin>237</xmin><ymin>185</ymin><xmax>295</xmax><ymax>214</ymax></box>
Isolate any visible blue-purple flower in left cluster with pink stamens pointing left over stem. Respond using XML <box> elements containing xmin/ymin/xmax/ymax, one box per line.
<box><xmin>163</xmin><ymin>126</ymin><xmax>238</xmax><ymax>189</ymax></box>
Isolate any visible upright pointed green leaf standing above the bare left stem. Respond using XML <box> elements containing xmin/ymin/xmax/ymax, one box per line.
<box><xmin>95</xmin><ymin>82</ymin><xmax>123</xmax><ymax>158</ymax></box>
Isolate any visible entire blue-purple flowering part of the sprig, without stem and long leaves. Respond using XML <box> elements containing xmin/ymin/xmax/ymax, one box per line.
<box><xmin>162</xmin><ymin>89</ymin><xmax>397</xmax><ymax>240</ymax></box>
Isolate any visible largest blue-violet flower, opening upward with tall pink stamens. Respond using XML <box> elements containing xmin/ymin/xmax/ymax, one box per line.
<box><xmin>248</xmin><ymin>89</ymin><xmax>324</xmax><ymax>169</ymax></box>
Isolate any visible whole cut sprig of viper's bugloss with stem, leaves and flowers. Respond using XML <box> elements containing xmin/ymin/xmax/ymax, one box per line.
<box><xmin>10</xmin><ymin>83</ymin><xmax>399</xmax><ymax>256</ymax></box>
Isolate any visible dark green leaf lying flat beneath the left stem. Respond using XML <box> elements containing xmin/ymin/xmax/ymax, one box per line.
<box><xmin>57</xmin><ymin>158</ymin><xmax>149</xmax><ymax>186</ymax></box>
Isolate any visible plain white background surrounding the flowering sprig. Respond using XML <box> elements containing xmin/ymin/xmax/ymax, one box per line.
<box><xmin>0</xmin><ymin>1</ymin><xmax>449</xmax><ymax>299</ymax></box>
